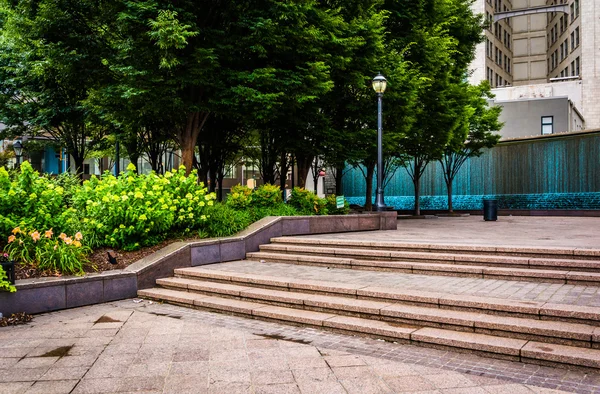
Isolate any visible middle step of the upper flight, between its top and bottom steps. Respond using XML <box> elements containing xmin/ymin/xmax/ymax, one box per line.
<box><xmin>260</xmin><ymin>243</ymin><xmax>600</xmax><ymax>269</ymax></box>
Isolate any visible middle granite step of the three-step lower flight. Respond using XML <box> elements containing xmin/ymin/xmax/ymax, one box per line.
<box><xmin>156</xmin><ymin>278</ymin><xmax>600</xmax><ymax>348</ymax></box>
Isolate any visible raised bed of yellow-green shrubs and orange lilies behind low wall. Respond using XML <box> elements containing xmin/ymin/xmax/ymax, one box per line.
<box><xmin>0</xmin><ymin>162</ymin><xmax>347</xmax><ymax>278</ymax></box>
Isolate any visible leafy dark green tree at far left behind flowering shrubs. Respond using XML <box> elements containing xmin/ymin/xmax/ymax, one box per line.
<box><xmin>0</xmin><ymin>0</ymin><xmax>112</xmax><ymax>174</ymax></box>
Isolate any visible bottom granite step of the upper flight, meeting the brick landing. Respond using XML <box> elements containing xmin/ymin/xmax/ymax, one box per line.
<box><xmin>246</xmin><ymin>252</ymin><xmax>600</xmax><ymax>285</ymax></box>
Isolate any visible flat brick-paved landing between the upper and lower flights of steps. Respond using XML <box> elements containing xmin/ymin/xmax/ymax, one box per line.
<box><xmin>203</xmin><ymin>260</ymin><xmax>600</xmax><ymax>306</ymax></box>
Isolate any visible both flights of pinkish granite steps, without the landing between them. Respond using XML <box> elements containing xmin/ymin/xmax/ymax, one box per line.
<box><xmin>138</xmin><ymin>237</ymin><xmax>600</xmax><ymax>369</ymax></box>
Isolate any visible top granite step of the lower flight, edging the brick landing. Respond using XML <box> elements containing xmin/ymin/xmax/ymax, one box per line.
<box><xmin>171</xmin><ymin>267</ymin><xmax>600</xmax><ymax>326</ymax></box>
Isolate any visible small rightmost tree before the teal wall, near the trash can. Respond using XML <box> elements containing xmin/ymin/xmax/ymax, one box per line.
<box><xmin>440</xmin><ymin>81</ymin><xmax>503</xmax><ymax>213</ymax></box>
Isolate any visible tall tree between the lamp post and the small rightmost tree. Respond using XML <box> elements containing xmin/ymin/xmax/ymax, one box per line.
<box><xmin>386</xmin><ymin>0</ymin><xmax>483</xmax><ymax>215</ymax></box>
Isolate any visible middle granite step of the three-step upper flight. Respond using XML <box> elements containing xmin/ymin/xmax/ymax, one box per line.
<box><xmin>260</xmin><ymin>242</ymin><xmax>600</xmax><ymax>277</ymax></box>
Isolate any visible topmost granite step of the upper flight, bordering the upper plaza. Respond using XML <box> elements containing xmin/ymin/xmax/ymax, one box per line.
<box><xmin>270</xmin><ymin>237</ymin><xmax>600</xmax><ymax>258</ymax></box>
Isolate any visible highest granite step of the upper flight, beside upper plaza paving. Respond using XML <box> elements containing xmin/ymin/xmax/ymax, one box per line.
<box><xmin>271</xmin><ymin>237</ymin><xmax>600</xmax><ymax>260</ymax></box>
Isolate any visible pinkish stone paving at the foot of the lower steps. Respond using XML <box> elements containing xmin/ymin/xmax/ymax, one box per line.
<box><xmin>0</xmin><ymin>300</ymin><xmax>600</xmax><ymax>394</ymax></box>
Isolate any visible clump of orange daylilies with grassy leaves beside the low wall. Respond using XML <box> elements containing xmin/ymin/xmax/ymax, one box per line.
<box><xmin>5</xmin><ymin>227</ymin><xmax>91</xmax><ymax>275</ymax></box>
